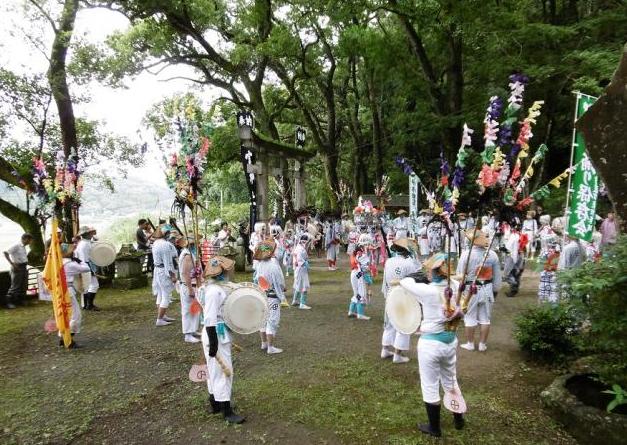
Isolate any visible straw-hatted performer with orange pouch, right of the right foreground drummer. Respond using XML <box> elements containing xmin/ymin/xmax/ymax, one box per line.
<box><xmin>457</xmin><ymin>229</ymin><xmax>501</xmax><ymax>352</ymax></box>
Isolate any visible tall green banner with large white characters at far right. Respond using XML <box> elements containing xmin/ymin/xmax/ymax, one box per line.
<box><xmin>567</xmin><ymin>94</ymin><xmax>599</xmax><ymax>241</ymax></box>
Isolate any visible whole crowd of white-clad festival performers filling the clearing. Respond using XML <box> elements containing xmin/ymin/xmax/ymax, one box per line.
<box><xmin>33</xmin><ymin>210</ymin><xmax>615</xmax><ymax>436</ymax></box>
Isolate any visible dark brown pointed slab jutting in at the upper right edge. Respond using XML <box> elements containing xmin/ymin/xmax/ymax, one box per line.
<box><xmin>577</xmin><ymin>45</ymin><xmax>627</xmax><ymax>233</ymax></box>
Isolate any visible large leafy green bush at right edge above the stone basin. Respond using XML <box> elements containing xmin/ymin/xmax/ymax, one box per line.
<box><xmin>558</xmin><ymin>235</ymin><xmax>627</xmax><ymax>388</ymax></box>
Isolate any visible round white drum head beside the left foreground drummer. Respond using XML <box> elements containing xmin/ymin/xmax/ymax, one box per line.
<box><xmin>222</xmin><ymin>283</ymin><xmax>268</xmax><ymax>334</ymax></box>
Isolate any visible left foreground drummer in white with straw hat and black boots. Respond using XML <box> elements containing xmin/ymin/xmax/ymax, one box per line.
<box><xmin>202</xmin><ymin>256</ymin><xmax>246</xmax><ymax>424</ymax></box>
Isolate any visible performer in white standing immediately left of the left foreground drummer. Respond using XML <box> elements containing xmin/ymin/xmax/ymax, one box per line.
<box><xmin>178</xmin><ymin>236</ymin><xmax>200</xmax><ymax>343</ymax></box>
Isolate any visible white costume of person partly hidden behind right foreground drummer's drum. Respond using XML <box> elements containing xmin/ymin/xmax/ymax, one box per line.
<box><xmin>381</xmin><ymin>255</ymin><xmax>420</xmax><ymax>351</ymax></box>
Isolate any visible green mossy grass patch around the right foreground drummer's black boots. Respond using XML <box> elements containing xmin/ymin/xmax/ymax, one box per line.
<box><xmin>238</xmin><ymin>357</ymin><xmax>576</xmax><ymax>445</ymax></box>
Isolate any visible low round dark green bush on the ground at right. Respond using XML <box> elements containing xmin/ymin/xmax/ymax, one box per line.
<box><xmin>514</xmin><ymin>303</ymin><xmax>581</xmax><ymax>364</ymax></box>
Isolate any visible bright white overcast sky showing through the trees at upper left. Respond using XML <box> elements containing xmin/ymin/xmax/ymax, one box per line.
<box><xmin>0</xmin><ymin>0</ymin><xmax>221</xmax><ymax>270</ymax></box>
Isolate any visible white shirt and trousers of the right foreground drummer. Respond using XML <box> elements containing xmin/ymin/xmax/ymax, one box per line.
<box><xmin>400</xmin><ymin>278</ymin><xmax>459</xmax><ymax>404</ymax></box>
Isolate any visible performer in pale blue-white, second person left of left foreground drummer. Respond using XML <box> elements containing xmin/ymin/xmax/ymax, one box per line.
<box><xmin>152</xmin><ymin>228</ymin><xmax>177</xmax><ymax>326</ymax></box>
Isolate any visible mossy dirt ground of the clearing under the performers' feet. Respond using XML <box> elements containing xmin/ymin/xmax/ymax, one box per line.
<box><xmin>0</xmin><ymin>253</ymin><xmax>576</xmax><ymax>445</ymax></box>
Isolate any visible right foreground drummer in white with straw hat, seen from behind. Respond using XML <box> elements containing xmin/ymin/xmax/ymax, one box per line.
<box><xmin>400</xmin><ymin>253</ymin><xmax>464</xmax><ymax>437</ymax></box>
